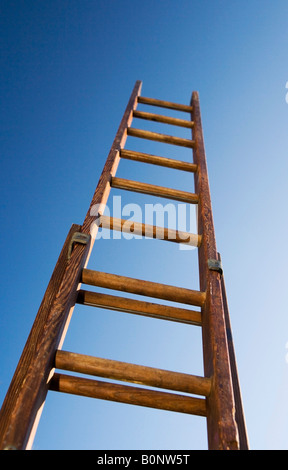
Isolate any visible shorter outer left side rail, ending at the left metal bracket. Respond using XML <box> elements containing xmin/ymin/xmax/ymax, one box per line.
<box><xmin>0</xmin><ymin>224</ymin><xmax>80</xmax><ymax>449</ymax></box>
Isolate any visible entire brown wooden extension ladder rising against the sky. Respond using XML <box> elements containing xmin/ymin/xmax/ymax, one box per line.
<box><xmin>0</xmin><ymin>81</ymin><xmax>248</xmax><ymax>450</ymax></box>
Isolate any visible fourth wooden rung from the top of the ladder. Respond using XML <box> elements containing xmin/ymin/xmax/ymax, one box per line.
<box><xmin>120</xmin><ymin>149</ymin><xmax>197</xmax><ymax>173</ymax></box>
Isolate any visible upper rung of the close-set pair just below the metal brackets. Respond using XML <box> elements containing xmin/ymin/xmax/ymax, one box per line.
<box><xmin>81</xmin><ymin>269</ymin><xmax>206</xmax><ymax>307</ymax></box>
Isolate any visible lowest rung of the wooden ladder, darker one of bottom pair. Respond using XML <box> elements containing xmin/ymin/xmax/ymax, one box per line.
<box><xmin>49</xmin><ymin>373</ymin><xmax>207</xmax><ymax>416</ymax></box>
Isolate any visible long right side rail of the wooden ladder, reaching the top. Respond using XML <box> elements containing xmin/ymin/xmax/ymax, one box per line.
<box><xmin>191</xmin><ymin>92</ymin><xmax>239</xmax><ymax>450</ymax></box>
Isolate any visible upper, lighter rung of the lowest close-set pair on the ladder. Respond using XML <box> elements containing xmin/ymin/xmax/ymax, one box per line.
<box><xmin>55</xmin><ymin>350</ymin><xmax>211</xmax><ymax>397</ymax></box>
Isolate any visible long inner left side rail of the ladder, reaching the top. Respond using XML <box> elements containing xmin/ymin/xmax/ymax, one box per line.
<box><xmin>0</xmin><ymin>81</ymin><xmax>142</xmax><ymax>450</ymax></box>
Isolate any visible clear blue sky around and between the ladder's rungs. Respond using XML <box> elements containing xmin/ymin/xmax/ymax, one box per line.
<box><xmin>0</xmin><ymin>0</ymin><xmax>288</xmax><ymax>449</ymax></box>
